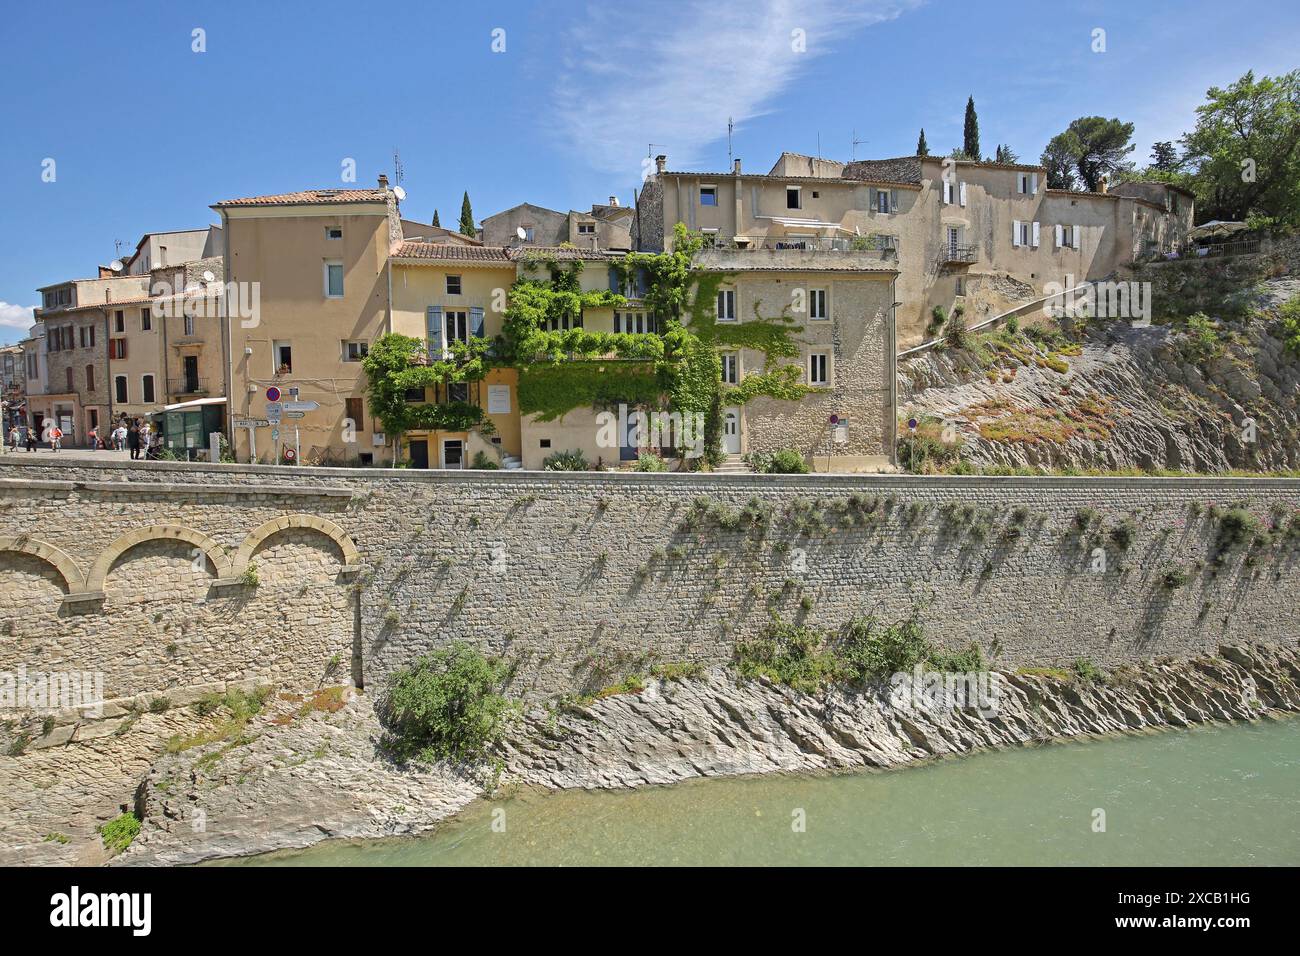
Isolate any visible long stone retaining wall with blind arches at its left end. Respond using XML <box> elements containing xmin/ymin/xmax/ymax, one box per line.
<box><xmin>0</xmin><ymin>459</ymin><xmax>1300</xmax><ymax>717</ymax></box>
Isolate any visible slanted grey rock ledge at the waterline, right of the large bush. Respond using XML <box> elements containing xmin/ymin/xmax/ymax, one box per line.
<box><xmin>507</xmin><ymin>646</ymin><xmax>1300</xmax><ymax>788</ymax></box>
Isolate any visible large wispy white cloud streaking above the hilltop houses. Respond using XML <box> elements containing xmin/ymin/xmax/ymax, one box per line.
<box><xmin>554</xmin><ymin>0</ymin><xmax>920</xmax><ymax>179</ymax></box>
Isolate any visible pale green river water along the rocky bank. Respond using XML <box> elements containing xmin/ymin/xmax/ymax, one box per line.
<box><xmin>229</xmin><ymin>719</ymin><xmax>1300</xmax><ymax>866</ymax></box>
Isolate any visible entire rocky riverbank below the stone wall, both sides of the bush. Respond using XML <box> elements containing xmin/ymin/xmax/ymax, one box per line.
<box><xmin>101</xmin><ymin>645</ymin><xmax>1300</xmax><ymax>865</ymax></box>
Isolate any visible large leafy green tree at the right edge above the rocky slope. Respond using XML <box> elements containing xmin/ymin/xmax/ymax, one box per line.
<box><xmin>1182</xmin><ymin>70</ymin><xmax>1300</xmax><ymax>226</ymax></box>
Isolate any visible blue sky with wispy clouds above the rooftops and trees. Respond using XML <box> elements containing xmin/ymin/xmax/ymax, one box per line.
<box><xmin>0</xmin><ymin>0</ymin><xmax>1300</xmax><ymax>342</ymax></box>
